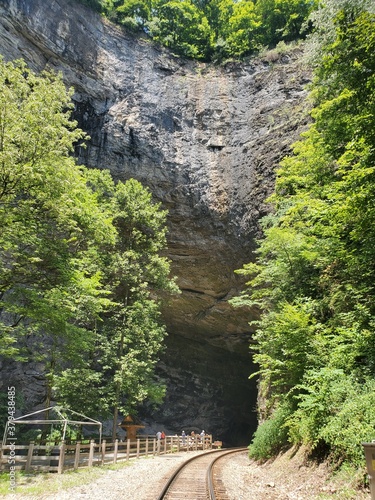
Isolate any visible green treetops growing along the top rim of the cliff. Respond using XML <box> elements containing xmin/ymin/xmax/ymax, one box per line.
<box><xmin>80</xmin><ymin>0</ymin><xmax>318</xmax><ymax>61</ymax></box>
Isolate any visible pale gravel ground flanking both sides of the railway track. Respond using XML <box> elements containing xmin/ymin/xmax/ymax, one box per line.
<box><xmin>3</xmin><ymin>451</ymin><xmax>369</xmax><ymax>500</ymax></box>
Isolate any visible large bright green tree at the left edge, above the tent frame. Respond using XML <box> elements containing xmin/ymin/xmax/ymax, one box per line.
<box><xmin>0</xmin><ymin>60</ymin><xmax>115</xmax><ymax>403</ymax></box>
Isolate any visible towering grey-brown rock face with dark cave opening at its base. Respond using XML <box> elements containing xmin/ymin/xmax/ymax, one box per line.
<box><xmin>0</xmin><ymin>0</ymin><xmax>309</xmax><ymax>442</ymax></box>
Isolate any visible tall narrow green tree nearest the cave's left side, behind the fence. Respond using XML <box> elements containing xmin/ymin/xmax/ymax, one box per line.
<box><xmin>106</xmin><ymin>179</ymin><xmax>176</xmax><ymax>437</ymax></box>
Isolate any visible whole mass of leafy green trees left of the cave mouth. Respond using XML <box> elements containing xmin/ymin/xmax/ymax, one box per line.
<box><xmin>0</xmin><ymin>59</ymin><xmax>176</xmax><ymax>434</ymax></box>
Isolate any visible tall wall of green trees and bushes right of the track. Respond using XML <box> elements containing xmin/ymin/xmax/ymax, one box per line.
<box><xmin>234</xmin><ymin>0</ymin><xmax>375</xmax><ymax>467</ymax></box>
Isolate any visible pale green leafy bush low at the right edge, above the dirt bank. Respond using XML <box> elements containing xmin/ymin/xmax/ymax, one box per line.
<box><xmin>287</xmin><ymin>367</ymin><xmax>375</xmax><ymax>467</ymax></box>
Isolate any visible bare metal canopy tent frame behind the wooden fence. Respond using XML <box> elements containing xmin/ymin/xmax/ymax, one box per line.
<box><xmin>3</xmin><ymin>406</ymin><xmax>103</xmax><ymax>446</ymax></box>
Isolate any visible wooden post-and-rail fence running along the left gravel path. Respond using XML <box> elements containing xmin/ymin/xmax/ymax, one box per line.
<box><xmin>0</xmin><ymin>435</ymin><xmax>214</xmax><ymax>474</ymax></box>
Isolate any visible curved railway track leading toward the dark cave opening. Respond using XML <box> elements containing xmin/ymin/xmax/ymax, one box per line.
<box><xmin>156</xmin><ymin>448</ymin><xmax>247</xmax><ymax>500</ymax></box>
